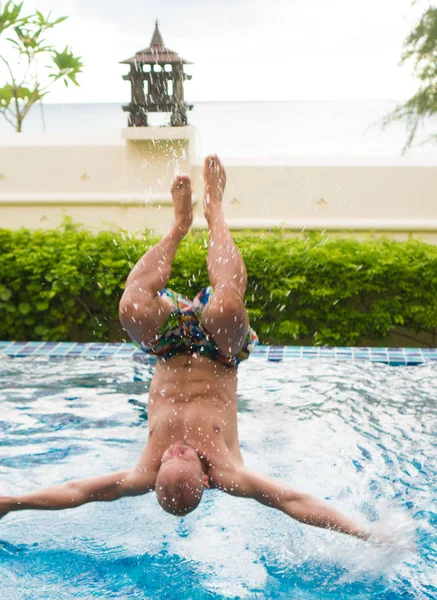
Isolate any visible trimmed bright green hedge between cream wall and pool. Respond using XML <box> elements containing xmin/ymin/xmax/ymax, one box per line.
<box><xmin>0</xmin><ymin>224</ymin><xmax>437</xmax><ymax>346</ymax></box>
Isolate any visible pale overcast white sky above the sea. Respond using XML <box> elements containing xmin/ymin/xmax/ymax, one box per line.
<box><xmin>0</xmin><ymin>0</ymin><xmax>425</xmax><ymax>103</ymax></box>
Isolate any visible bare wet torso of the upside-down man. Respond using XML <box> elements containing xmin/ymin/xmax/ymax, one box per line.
<box><xmin>141</xmin><ymin>354</ymin><xmax>243</xmax><ymax>474</ymax></box>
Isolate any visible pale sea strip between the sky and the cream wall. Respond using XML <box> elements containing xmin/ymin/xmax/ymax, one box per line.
<box><xmin>0</xmin><ymin>99</ymin><xmax>437</xmax><ymax>161</ymax></box>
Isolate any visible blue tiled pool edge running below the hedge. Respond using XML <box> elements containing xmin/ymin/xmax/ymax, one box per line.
<box><xmin>0</xmin><ymin>341</ymin><xmax>437</xmax><ymax>366</ymax></box>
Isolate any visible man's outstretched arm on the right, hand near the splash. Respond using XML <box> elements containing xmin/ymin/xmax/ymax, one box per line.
<box><xmin>213</xmin><ymin>467</ymin><xmax>369</xmax><ymax>540</ymax></box>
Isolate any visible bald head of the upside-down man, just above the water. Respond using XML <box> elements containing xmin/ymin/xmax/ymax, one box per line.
<box><xmin>155</xmin><ymin>443</ymin><xmax>209</xmax><ymax>516</ymax></box>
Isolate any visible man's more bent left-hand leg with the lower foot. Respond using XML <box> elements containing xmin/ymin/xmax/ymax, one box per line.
<box><xmin>119</xmin><ymin>175</ymin><xmax>193</xmax><ymax>343</ymax></box>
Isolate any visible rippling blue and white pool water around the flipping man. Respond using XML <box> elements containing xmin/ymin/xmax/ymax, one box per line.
<box><xmin>0</xmin><ymin>356</ymin><xmax>437</xmax><ymax>600</ymax></box>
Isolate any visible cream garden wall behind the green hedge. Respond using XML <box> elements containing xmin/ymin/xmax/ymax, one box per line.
<box><xmin>0</xmin><ymin>127</ymin><xmax>437</xmax><ymax>243</ymax></box>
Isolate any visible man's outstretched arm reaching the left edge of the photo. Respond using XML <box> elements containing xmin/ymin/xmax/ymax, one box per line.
<box><xmin>0</xmin><ymin>467</ymin><xmax>155</xmax><ymax>518</ymax></box>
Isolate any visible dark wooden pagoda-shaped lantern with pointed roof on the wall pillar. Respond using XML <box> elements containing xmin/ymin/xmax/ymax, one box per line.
<box><xmin>120</xmin><ymin>21</ymin><xmax>193</xmax><ymax>127</ymax></box>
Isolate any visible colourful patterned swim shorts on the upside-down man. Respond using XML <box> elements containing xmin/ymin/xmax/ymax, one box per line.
<box><xmin>141</xmin><ymin>287</ymin><xmax>258</xmax><ymax>367</ymax></box>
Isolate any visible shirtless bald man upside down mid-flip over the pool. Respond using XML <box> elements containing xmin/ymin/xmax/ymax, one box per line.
<box><xmin>0</xmin><ymin>156</ymin><xmax>369</xmax><ymax>539</ymax></box>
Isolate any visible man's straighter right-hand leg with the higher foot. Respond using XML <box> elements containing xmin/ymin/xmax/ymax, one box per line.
<box><xmin>202</xmin><ymin>156</ymin><xmax>249</xmax><ymax>356</ymax></box>
